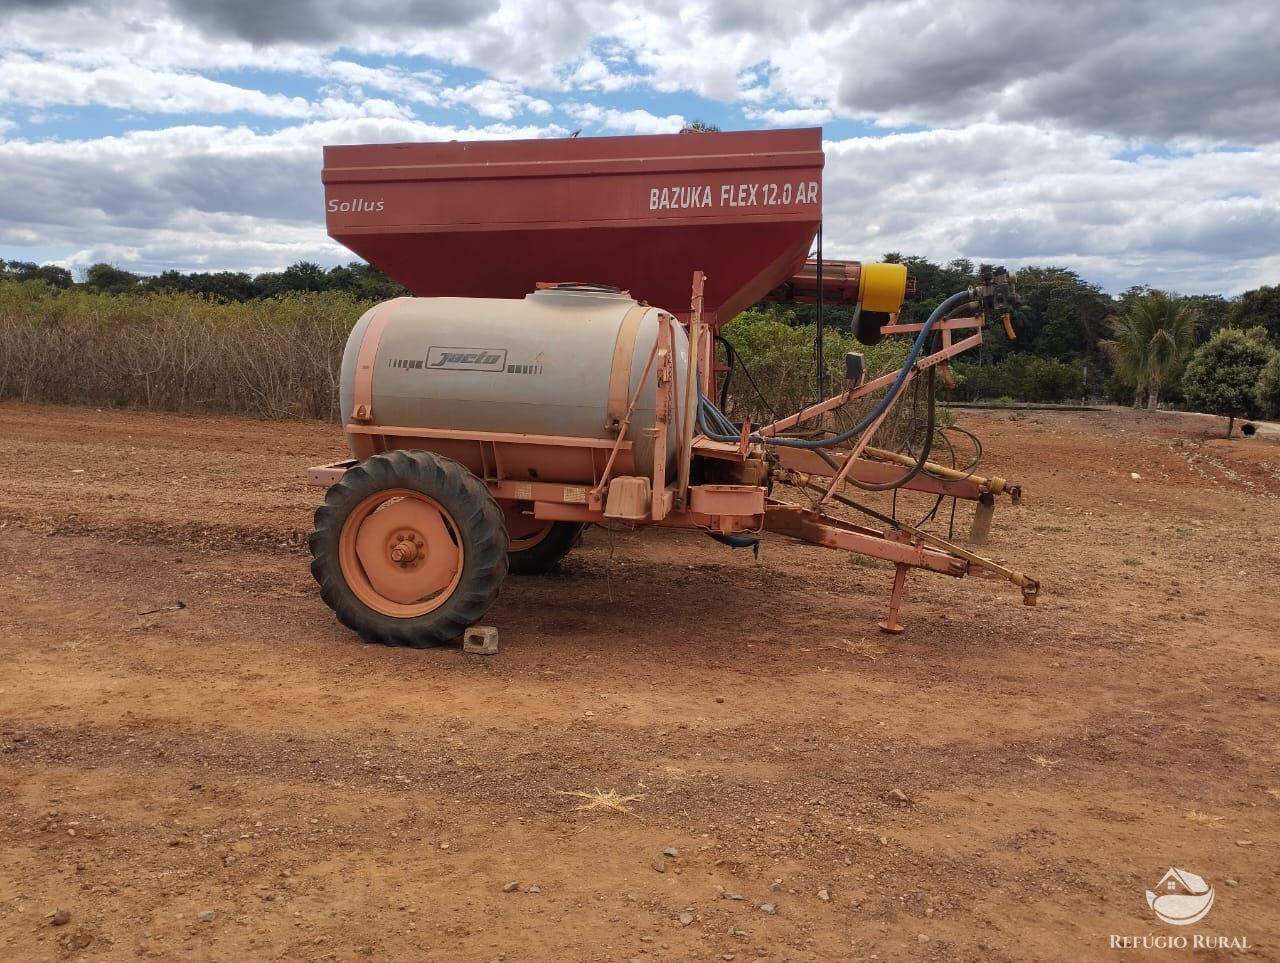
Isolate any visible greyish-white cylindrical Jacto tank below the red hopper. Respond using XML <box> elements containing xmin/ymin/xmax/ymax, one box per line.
<box><xmin>340</xmin><ymin>286</ymin><xmax>689</xmax><ymax>480</ymax></box>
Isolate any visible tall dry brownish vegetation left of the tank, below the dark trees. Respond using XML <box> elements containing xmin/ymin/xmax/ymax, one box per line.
<box><xmin>0</xmin><ymin>282</ymin><xmax>355</xmax><ymax>419</ymax></box>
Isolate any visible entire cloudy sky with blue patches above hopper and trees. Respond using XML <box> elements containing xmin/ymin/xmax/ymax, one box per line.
<box><xmin>0</xmin><ymin>0</ymin><xmax>1280</xmax><ymax>295</ymax></box>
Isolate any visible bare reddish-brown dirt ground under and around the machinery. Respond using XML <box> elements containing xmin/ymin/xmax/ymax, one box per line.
<box><xmin>0</xmin><ymin>405</ymin><xmax>1280</xmax><ymax>963</ymax></box>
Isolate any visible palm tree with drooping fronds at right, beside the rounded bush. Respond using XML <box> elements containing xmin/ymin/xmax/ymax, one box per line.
<box><xmin>1098</xmin><ymin>291</ymin><xmax>1197</xmax><ymax>411</ymax></box>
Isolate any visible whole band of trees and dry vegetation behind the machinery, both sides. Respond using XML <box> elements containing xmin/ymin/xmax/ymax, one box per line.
<box><xmin>0</xmin><ymin>252</ymin><xmax>1280</xmax><ymax>420</ymax></box>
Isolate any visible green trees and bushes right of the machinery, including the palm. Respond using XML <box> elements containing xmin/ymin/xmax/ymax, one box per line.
<box><xmin>756</xmin><ymin>252</ymin><xmax>1280</xmax><ymax>425</ymax></box>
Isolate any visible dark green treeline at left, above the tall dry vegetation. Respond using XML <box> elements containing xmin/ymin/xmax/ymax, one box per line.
<box><xmin>0</xmin><ymin>260</ymin><xmax>410</xmax><ymax>302</ymax></box>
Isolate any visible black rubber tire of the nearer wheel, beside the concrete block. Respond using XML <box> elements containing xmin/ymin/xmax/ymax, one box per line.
<box><xmin>307</xmin><ymin>451</ymin><xmax>507</xmax><ymax>648</ymax></box>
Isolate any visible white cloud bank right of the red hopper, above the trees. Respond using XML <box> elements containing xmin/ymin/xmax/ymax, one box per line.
<box><xmin>823</xmin><ymin>123</ymin><xmax>1280</xmax><ymax>293</ymax></box>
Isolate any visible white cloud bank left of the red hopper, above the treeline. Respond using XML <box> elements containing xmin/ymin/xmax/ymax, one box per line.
<box><xmin>0</xmin><ymin>118</ymin><xmax>566</xmax><ymax>273</ymax></box>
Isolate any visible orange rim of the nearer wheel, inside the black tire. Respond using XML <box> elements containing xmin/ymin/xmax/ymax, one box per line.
<box><xmin>338</xmin><ymin>488</ymin><xmax>466</xmax><ymax>619</ymax></box>
